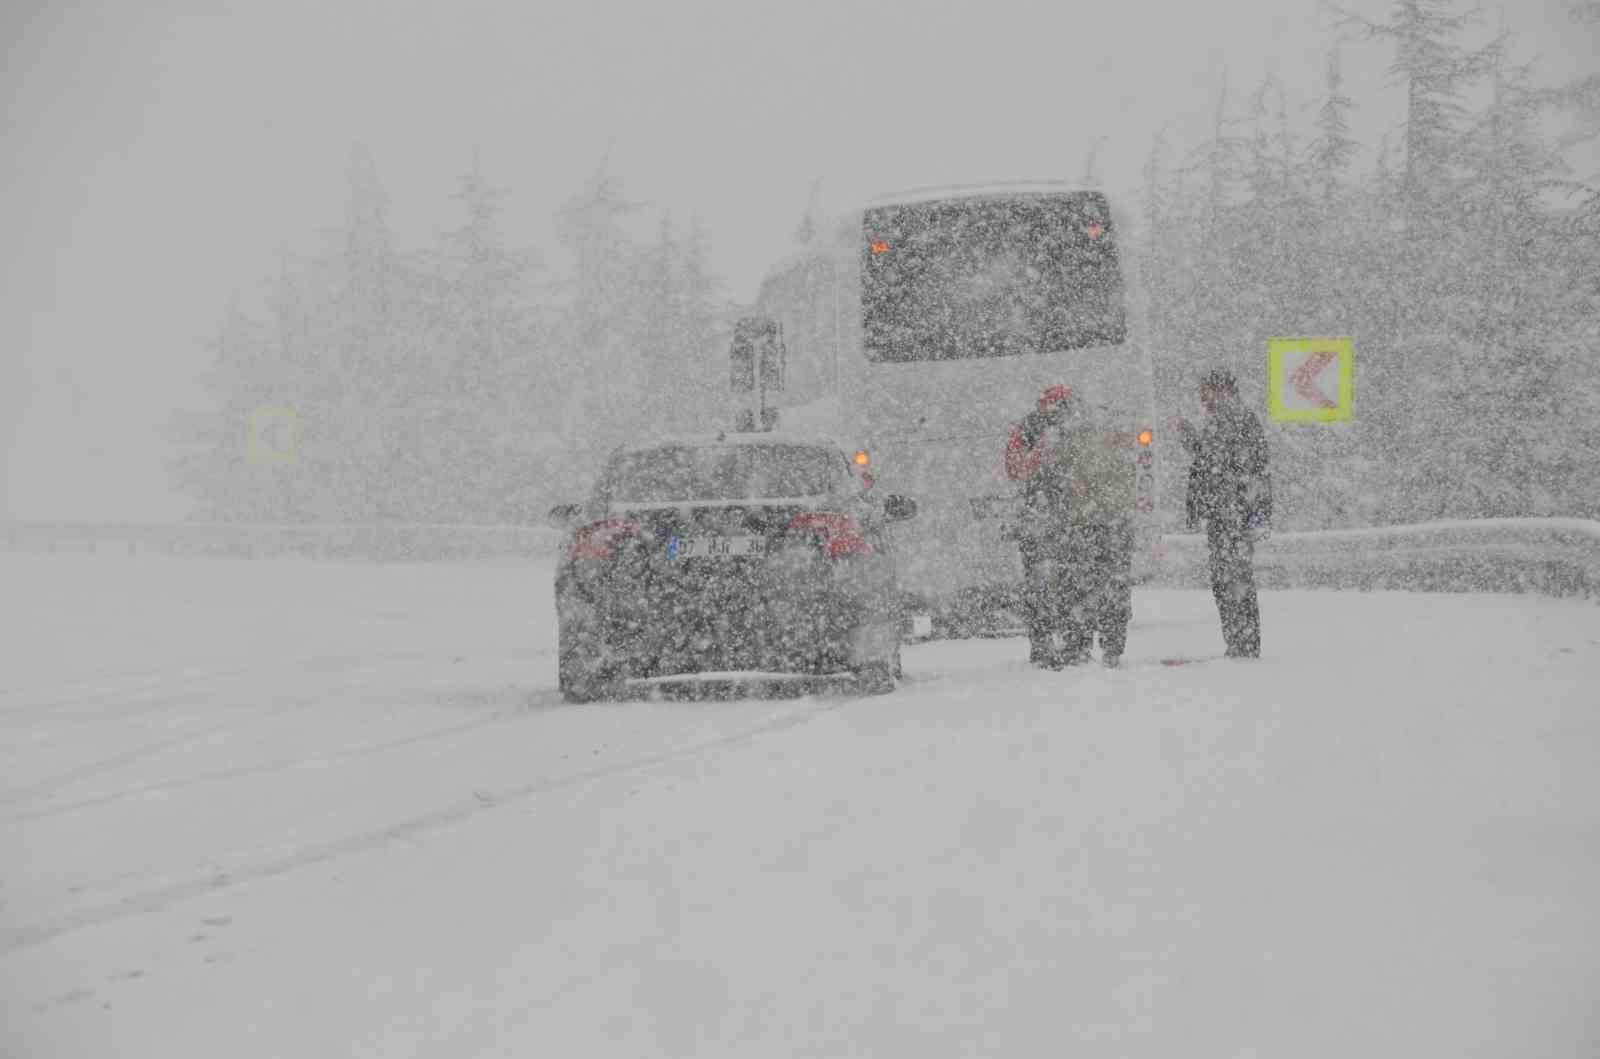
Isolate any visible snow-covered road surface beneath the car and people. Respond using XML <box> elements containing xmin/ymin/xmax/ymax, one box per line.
<box><xmin>0</xmin><ymin>555</ymin><xmax>1600</xmax><ymax>1057</ymax></box>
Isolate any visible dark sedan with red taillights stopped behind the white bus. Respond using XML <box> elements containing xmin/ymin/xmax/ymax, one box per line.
<box><xmin>550</xmin><ymin>435</ymin><xmax>917</xmax><ymax>702</ymax></box>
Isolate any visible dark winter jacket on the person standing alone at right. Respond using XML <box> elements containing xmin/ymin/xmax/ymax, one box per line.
<box><xmin>1187</xmin><ymin>403</ymin><xmax>1272</xmax><ymax>533</ymax></box>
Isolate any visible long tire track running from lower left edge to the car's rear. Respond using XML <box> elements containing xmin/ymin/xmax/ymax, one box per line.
<box><xmin>0</xmin><ymin>689</ymin><xmax>859</xmax><ymax>955</ymax></box>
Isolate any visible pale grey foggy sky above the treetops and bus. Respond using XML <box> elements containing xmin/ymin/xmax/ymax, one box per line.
<box><xmin>0</xmin><ymin>0</ymin><xmax>1600</xmax><ymax>518</ymax></box>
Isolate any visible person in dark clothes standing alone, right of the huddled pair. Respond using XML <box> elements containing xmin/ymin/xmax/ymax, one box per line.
<box><xmin>1184</xmin><ymin>370</ymin><xmax>1272</xmax><ymax>657</ymax></box>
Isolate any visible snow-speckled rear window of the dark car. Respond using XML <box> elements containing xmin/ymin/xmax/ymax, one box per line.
<box><xmin>606</xmin><ymin>445</ymin><xmax>845</xmax><ymax>501</ymax></box>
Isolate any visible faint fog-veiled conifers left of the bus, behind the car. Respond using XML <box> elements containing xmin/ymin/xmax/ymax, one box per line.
<box><xmin>173</xmin><ymin>152</ymin><xmax>728</xmax><ymax>523</ymax></box>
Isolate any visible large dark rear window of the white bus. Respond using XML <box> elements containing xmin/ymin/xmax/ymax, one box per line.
<box><xmin>861</xmin><ymin>192</ymin><xmax>1126</xmax><ymax>362</ymax></box>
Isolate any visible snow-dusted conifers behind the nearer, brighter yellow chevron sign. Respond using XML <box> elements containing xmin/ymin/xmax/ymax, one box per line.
<box><xmin>1136</xmin><ymin>0</ymin><xmax>1600</xmax><ymax>528</ymax></box>
